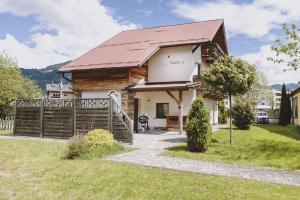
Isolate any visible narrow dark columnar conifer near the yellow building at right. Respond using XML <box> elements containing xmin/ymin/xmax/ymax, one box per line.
<box><xmin>279</xmin><ymin>84</ymin><xmax>292</xmax><ymax>126</ymax></box>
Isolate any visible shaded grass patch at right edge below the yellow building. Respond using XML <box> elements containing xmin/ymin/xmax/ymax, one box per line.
<box><xmin>258</xmin><ymin>124</ymin><xmax>300</xmax><ymax>140</ymax></box>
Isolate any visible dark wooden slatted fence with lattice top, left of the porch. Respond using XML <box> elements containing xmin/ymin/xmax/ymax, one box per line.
<box><xmin>14</xmin><ymin>98</ymin><xmax>133</xmax><ymax>143</ymax></box>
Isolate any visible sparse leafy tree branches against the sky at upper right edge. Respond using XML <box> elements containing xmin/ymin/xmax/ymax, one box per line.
<box><xmin>268</xmin><ymin>23</ymin><xmax>300</xmax><ymax>70</ymax></box>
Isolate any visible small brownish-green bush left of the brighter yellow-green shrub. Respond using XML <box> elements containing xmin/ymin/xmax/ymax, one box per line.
<box><xmin>66</xmin><ymin>135</ymin><xmax>89</xmax><ymax>159</ymax></box>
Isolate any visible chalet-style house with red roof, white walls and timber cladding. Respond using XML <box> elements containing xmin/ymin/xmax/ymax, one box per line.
<box><xmin>59</xmin><ymin>19</ymin><xmax>228</xmax><ymax>132</ymax></box>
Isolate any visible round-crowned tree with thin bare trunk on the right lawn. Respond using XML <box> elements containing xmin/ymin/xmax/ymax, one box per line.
<box><xmin>202</xmin><ymin>56</ymin><xmax>257</xmax><ymax>144</ymax></box>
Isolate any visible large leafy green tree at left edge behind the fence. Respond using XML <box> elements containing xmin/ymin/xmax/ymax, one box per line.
<box><xmin>0</xmin><ymin>52</ymin><xmax>41</xmax><ymax>116</ymax></box>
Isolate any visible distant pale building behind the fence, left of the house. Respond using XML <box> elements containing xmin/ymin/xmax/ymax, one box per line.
<box><xmin>46</xmin><ymin>82</ymin><xmax>75</xmax><ymax>99</ymax></box>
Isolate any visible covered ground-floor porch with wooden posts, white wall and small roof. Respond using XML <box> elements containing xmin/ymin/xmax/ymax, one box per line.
<box><xmin>128</xmin><ymin>82</ymin><xmax>218</xmax><ymax>133</ymax></box>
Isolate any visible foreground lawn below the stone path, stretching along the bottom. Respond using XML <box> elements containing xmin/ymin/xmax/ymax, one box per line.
<box><xmin>0</xmin><ymin>139</ymin><xmax>300</xmax><ymax>200</ymax></box>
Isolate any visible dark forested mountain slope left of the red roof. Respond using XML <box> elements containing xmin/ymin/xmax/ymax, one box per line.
<box><xmin>21</xmin><ymin>61</ymin><xmax>70</xmax><ymax>91</ymax></box>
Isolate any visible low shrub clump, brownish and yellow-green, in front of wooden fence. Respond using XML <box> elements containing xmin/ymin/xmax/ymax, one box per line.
<box><xmin>66</xmin><ymin>129</ymin><xmax>124</xmax><ymax>159</ymax></box>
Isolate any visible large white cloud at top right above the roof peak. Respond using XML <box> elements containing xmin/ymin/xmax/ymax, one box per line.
<box><xmin>173</xmin><ymin>0</ymin><xmax>300</xmax><ymax>38</ymax></box>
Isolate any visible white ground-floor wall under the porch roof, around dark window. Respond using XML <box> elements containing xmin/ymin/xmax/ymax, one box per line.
<box><xmin>135</xmin><ymin>90</ymin><xmax>196</xmax><ymax>128</ymax></box>
